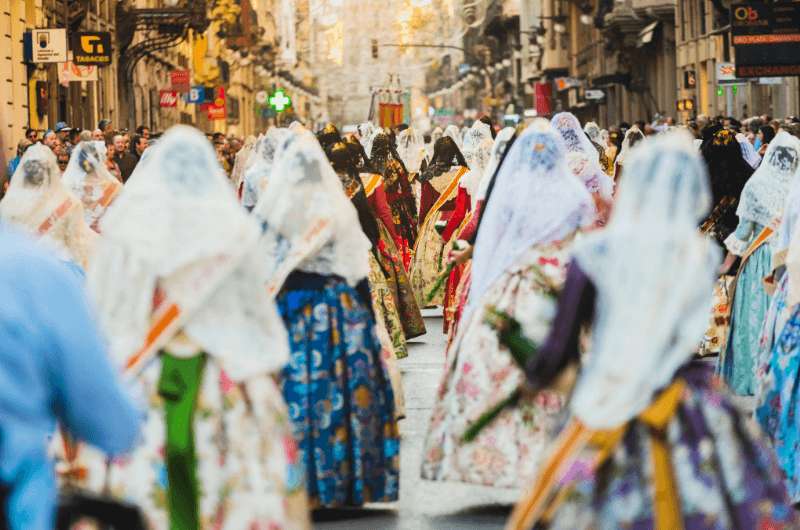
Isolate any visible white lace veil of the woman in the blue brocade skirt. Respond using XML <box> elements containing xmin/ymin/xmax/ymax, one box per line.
<box><xmin>253</xmin><ymin>128</ymin><xmax>371</xmax><ymax>293</ymax></box>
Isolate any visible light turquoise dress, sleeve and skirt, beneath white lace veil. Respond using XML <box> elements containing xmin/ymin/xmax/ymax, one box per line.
<box><xmin>717</xmin><ymin>217</ymin><xmax>772</xmax><ymax>396</ymax></box>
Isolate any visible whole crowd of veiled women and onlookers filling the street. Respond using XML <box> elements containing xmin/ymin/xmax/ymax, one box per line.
<box><xmin>0</xmin><ymin>104</ymin><xmax>800</xmax><ymax>530</ymax></box>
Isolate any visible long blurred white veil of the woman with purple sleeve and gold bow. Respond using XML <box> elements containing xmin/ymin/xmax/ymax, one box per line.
<box><xmin>571</xmin><ymin>132</ymin><xmax>720</xmax><ymax>429</ymax></box>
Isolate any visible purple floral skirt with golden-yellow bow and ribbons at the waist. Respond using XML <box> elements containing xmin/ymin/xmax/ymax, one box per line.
<box><xmin>507</xmin><ymin>363</ymin><xmax>800</xmax><ymax>530</ymax></box>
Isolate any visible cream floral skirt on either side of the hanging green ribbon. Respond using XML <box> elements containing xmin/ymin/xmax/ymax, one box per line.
<box><xmin>75</xmin><ymin>348</ymin><xmax>310</xmax><ymax>530</ymax></box>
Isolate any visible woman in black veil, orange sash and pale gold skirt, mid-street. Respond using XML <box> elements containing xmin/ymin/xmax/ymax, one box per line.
<box><xmin>411</xmin><ymin>136</ymin><xmax>469</xmax><ymax>307</ymax></box>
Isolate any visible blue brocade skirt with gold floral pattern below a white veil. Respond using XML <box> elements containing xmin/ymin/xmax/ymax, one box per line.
<box><xmin>278</xmin><ymin>272</ymin><xmax>400</xmax><ymax>507</ymax></box>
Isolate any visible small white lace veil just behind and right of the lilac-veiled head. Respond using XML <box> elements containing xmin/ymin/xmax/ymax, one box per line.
<box><xmin>551</xmin><ymin>112</ymin><xmax>614</xmax><ymax>199</ymax></box>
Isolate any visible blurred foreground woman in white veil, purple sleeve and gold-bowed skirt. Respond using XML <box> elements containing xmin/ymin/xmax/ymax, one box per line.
<box><xmin>506</xmin><ymin>128</ymin><xmax>800</xmax><ymax>530</ymax></box>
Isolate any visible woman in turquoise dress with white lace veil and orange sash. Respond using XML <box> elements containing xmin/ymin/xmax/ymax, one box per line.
<box><xmin>717</xmin><ymin>132</ymin><xmax>800</xmax><ymax>395</ymax></box>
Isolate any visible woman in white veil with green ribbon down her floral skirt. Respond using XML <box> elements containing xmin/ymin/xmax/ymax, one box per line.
<box><xmin>87</xmin><ymin>126</ymin><xmax>310</xmax><ymax>530</ymax></box>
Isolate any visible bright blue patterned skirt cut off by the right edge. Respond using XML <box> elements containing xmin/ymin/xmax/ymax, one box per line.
<box><xmin>755</xmin><ymin>306</ymin><xmax>800</xmax><ymax>503</ymax></box>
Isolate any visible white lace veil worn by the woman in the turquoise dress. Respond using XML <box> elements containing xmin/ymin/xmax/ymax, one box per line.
<box><xmin>736</xmin><ymin>131</ymin><xmax>800</xmax><ymax>226</ymax></box>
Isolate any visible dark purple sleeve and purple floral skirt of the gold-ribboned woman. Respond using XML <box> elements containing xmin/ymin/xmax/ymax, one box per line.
<box><xmin>528</xmin><ymin>263</ymin><xmax>800</xmax><ymax>530</ymax></box>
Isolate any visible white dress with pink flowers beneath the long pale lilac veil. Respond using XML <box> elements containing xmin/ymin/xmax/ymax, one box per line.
<box><xmin>422</xmin><ymin>244</ymin><xmax>568</xmax><ymax>488</ymax></box>
